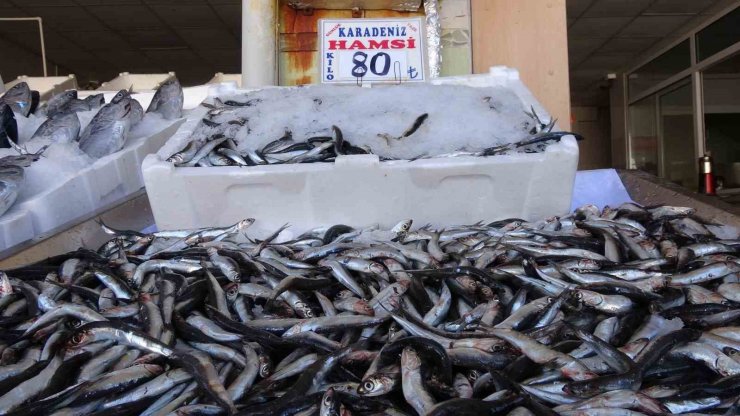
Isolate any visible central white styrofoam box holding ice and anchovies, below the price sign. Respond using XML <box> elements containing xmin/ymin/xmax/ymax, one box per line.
<box><xmin>142</xmin><ymin>68</ymin><xmax>578</xmax><ymax>236</ymax></box>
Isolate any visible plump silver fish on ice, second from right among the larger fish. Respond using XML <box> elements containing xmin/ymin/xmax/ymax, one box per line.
<box><xmin>79</xmin><ymin>90</ymin><xmax>138</xmax><ymax>159</ymax></box>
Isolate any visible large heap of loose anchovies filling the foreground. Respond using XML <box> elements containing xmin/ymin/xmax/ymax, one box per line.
<box><xmin>0</xmin><ymin>203</ymin><xmax>740</xmax><ymax>416</ymax></box>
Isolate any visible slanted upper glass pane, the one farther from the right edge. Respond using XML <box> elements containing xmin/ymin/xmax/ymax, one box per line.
<box><xmin>629</xmin><ymin>39</ymin><xmax>691</xmax><ymax>97</ymax></box>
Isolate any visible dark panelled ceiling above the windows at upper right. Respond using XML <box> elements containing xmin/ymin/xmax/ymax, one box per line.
<box><xmin>566</xmin><ymin>0</ymin><xmax>737</xmax><ymax>106</ymax></box>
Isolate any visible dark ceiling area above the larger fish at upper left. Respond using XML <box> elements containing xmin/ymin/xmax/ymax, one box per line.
<box><xmin>0</xmin><ymin>0</ymin><xmax>241</xmax><ymax>85</ymax></box>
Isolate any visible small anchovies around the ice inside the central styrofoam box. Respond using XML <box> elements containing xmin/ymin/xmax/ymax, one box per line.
<box><xmin>167</xmin><ymin>99</ymin><xmax>583</xmax><ymax>167</ymax></box>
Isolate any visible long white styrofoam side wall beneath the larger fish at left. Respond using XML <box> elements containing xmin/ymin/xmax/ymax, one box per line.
<box><xmin>0</xmin><ymin>119</ymin><xmax>185</xmax><ymax>250</ymax></box>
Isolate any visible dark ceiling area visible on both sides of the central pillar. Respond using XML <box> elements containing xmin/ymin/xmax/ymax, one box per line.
<box><xmin>0</xmin><ymin>0</ymin><xmax>736</xmax><ymax>96</ymax></box>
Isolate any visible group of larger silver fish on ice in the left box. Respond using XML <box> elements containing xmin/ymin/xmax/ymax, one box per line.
<box><xmin>0</xmin><ymin>79</ymin><xmax>183</xmax><ymax>219</ymax></box>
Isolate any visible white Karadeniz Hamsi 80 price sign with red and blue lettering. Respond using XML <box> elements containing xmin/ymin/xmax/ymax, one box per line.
<box><xmin>319</xmin><ymin>17</ymin><xmax>425</xmax><ymax>84</ymax></box>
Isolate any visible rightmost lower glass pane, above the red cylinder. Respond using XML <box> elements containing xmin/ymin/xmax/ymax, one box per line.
<box><xmin>702</xmin><ymin>54</ymin><xmax>740</xmax><ymax>188</ymax></box>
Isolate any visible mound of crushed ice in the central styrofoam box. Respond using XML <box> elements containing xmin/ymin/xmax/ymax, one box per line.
<box><xmin>184</xmin><ymin>85</ymin><xmax>535</xmax><ymax>159</ymax></box>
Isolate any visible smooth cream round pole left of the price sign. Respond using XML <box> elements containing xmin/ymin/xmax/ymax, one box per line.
<box><xmin>242</xmin><ymin>0</ymin><xmax>277</xmax><ymax>88</ymax></box>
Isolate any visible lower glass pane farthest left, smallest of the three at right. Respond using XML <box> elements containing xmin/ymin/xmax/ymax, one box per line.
<box><xmin>629</xmin><ymin>95</ymin><xmax>658</xmax><ymax>175</ymax></box>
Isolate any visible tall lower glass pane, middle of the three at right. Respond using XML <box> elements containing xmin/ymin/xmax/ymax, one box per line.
<box><xmin>659</xmin><ymin>81</ymin><xmax>698</xmax><ymax>189</ymax></box>
